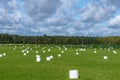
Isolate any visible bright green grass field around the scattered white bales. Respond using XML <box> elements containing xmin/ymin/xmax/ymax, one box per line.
<box><xmin>0</xmin><ymin>44</ymin><xmax>120</xmax><ymax>80</ymax></box>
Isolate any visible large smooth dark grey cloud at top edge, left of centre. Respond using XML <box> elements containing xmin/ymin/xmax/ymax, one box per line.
<box><xmin>24</xmin><ymin>0</ymin><xmax>60</xmax><ymax>21</ymax></box>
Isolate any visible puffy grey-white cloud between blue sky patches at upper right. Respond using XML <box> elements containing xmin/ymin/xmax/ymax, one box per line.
<box><xmin>81</xmin><ymin>1</ymin><xmax>116</xmax><ymax>23</ymax></box>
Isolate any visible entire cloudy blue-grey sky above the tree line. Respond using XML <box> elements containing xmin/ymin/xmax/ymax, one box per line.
<box><xmin>0</xmin><ymin>0</ymin><xmax>120</xmax><ymax>36</ymax></box>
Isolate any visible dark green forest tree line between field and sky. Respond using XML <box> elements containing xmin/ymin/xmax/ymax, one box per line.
<box><xmin>0</xmin><ymin>34</ymin><xmax>120</xmax><ymax>44</ymax></box>
